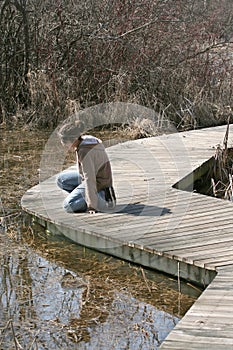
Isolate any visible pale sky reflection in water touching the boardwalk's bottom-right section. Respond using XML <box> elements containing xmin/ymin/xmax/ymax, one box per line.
<box><xmin>79</xmin><ymin>294</ymin><xmax>179</xmax><ymax>350</ymax></box>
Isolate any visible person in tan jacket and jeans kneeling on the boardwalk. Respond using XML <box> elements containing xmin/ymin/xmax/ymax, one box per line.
<box><xmin>57</xmin><ymin>125</ymin><xmax>116</xmax><ymax>213</ymax></box>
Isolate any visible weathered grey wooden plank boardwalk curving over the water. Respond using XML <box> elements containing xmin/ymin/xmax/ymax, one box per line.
<box><xmin>22</xmin><ymin>126</ymin><xmax>233</xmax><ymax>350</ymax></box>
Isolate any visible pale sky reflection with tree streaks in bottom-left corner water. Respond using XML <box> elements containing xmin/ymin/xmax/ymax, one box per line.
<box><xmin>0</xmin><ymin>247</ymin><xmax>86</xmax><ymax>349</ymax></box>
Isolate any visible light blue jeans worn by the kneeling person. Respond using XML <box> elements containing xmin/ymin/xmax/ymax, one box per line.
<box><xmin>57</xmin><ymin>170</ymin><xmax>106</xmax><ymax>213</ymax></box>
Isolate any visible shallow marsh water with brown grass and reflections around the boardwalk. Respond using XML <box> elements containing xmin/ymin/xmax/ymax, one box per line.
<box><xmin>0</xmin><ymin>129</ymin><xmax>201</xmax><ymax>350</ymax></box>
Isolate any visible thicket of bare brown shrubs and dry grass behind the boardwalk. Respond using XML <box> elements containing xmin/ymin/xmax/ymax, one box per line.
<box><xmin>0</xmin><ymin>0</ymin><xmax>233</xmax><ymax>129</ymax></box>
